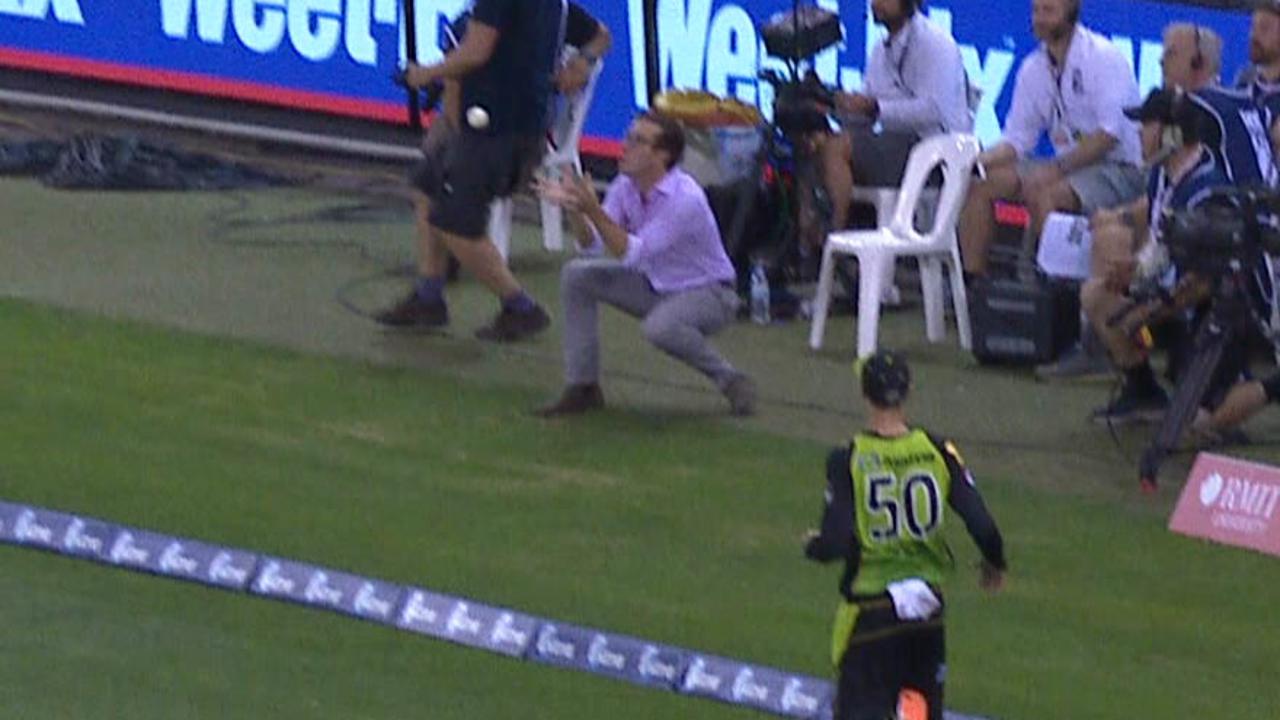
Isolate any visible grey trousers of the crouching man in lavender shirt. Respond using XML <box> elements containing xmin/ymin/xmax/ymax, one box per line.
<box><xmin>561</xmin><ymin>259</ymin><xmax>740</xmax><ymax>391</ymax></box>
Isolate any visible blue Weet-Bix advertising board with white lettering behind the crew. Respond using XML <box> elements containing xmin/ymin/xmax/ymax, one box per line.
<box><xmin>0</xmin><ymin>0</ymin><xmax>1248</xmax><ymax>146</ymax></box>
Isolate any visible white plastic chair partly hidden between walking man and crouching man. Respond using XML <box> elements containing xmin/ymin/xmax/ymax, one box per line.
<box><xmin>489</xmin><ymin>61</ymin><xmax>604</xmax><ymax>260</ymax></box>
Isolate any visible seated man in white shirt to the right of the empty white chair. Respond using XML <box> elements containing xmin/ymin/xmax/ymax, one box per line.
<box><xmin>959</xmin><ymin>0</ymin><xmax>1144</xmax><ymax>275</ymax></box>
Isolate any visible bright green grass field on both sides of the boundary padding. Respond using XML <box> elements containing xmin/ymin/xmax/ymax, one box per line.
<box><xmin>0</xmin><ymin>302</ymin><xmax>1280</xmax><ymax>719</ymax></box>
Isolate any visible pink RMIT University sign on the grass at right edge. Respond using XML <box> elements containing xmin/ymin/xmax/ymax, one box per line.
<box><xmin>1169</xmin><ymin>452</ymin><xmax>1280</xmax><ymax>556</ymax></box>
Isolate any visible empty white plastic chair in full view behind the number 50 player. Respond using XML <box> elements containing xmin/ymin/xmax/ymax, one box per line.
<box><xmin>809</xmin><ymin>135</ymin><xmax>980</xmax><ymax>357</ymax></box>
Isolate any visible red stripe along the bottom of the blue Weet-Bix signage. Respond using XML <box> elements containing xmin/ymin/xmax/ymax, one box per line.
<box><xmin>0</xmin><ymin>46</ymin><xmax>622</xmax><ymax>158</ymax></box>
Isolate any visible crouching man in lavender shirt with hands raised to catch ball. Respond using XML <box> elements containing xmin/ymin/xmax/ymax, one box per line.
<box><xmin>538</xmin><ymin>113</ymin><xmax>755</xmax><ymax>418</ymax></box>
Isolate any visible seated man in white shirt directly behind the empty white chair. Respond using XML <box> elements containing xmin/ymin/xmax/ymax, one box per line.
<box><xmin>820</xmin><ymin>0</ymin><xmax>973</xmax><ymax>229</ymax></box>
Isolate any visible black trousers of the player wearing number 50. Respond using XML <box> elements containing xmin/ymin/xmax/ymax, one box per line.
<box><xmin>832</xmin><ymin>594</ymin><xmax>946</xmax><ymax>720</ymax></box>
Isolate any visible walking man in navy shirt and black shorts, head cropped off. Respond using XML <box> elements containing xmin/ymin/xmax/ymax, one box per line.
<box><xmin>379</xmin><ymin>0</ymin><xmax>567</xmax><ymax>341</ymax></box>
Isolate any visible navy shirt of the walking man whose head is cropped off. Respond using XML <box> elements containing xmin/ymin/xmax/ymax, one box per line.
<box><xmin>462</xmin><ymin>0</ymin><xmax>566</xmax><ymax>135</ymax></box>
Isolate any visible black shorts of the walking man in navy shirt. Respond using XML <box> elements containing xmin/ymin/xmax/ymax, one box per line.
<box><xmin>410</xmin><ymin>131</ymin><xmax>547</xmax><ymax>240</ymax></box>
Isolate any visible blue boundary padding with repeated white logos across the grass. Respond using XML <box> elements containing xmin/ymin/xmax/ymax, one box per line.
<box><xmin>0</xmin><ymin>501</ymin><xmax>980</xmax><ymax>720</ymax></box>
